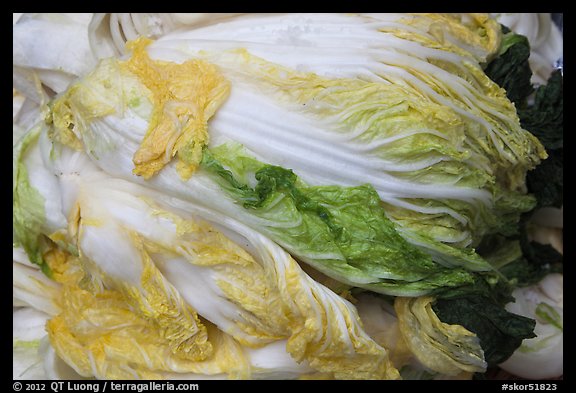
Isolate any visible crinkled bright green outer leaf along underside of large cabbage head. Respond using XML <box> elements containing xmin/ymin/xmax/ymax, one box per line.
<box><xmin>202</xmin><ymin>141</ymin><xmax>480</xmax><ymax>295</ymax></box>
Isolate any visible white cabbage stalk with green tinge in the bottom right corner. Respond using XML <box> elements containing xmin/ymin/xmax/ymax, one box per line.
<box><xmin>500</xmin><ymin>273</ymin><xmax>564</xmax><ymax>379</ymax></box>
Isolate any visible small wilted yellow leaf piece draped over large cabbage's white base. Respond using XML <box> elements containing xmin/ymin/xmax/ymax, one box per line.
<box><xmin>122</xmin><ymin>38</ymin><xmax>230</xmax><ymax>180</ymax></box>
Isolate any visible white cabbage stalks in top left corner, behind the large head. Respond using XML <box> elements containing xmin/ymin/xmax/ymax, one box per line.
<box><xmin>12</xmin><ymin>13</ymin><xmax>250</xmax><ymax>103</ymax></box>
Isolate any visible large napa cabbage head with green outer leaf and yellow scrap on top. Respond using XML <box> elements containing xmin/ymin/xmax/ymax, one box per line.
<box><xmin>51</xmin><ymin>14</ymin><xmax>546</xmax><ymax>296</ymax></box>
